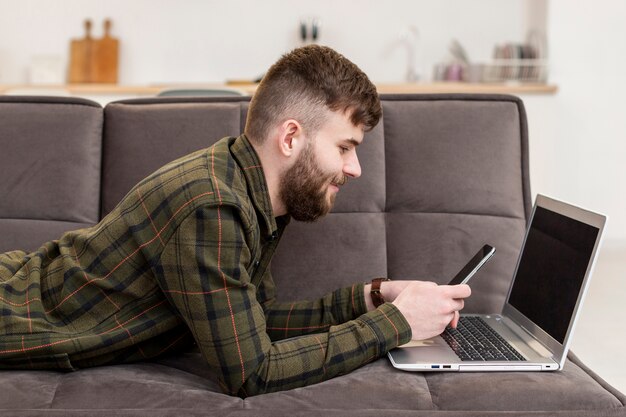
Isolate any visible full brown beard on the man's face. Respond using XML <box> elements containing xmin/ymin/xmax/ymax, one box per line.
<box><xmin>279</xmin><ymin>144</ymin><xmax>347</xmax><ymax>222</ymax></box>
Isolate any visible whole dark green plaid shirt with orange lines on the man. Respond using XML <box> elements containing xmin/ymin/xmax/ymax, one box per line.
<box><xmin>0</xmin><ymin>136</ymin><xmax>411</xmax><ymax>397</ymax></box>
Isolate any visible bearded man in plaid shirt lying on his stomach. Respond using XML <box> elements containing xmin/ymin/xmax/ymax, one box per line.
<box><xmin>0</xmin><ymin>46</ymin><xmax>470</xmax><ymax>397</ymax></box>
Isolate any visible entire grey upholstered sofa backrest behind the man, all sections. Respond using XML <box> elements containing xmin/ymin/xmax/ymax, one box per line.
<box><xmin>0</xmin><ymin>95</ymin><xmax>531</xmax><ymax>312</ymax></box>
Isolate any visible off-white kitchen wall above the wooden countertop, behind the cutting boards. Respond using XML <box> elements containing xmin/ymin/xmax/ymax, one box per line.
<box><xmin>0</xmin><ymin>0</ymin><xmax>526</xmax><ymax>85</ymax></box>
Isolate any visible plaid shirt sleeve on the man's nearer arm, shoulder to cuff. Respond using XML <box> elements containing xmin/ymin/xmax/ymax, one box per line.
<box><xmin>155</xmin><ymin>205</ymin><xmax>411</xmax><ymax>397</ymax></box>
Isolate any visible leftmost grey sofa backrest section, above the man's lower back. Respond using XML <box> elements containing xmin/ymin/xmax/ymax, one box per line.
<box><xmin>0</xmin><ymin>96</ymin><xmax>102</xmax><ymax>252</ymax></box>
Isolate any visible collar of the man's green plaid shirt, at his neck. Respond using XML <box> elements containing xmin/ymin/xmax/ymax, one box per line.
<box><xmin>230</xmin><ymin>135</ymin><xmax>289</xmax><ymax>236</ymax></box>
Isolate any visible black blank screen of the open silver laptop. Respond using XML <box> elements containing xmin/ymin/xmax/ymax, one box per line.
<box><xmin>509</xmin><ymin>207</ymin><xmax>599</xmax><ymax>343</ymax></box>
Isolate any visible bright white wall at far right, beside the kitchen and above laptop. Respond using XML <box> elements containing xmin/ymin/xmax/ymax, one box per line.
<box><xmin>524</xmin><ymin>0</ymin><xmax>626</xmax><ymax>245</ymax></box>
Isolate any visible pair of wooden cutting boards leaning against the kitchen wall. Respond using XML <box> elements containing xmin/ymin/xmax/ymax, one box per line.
<box><xmin>68</xmin><ymin>19</ymin><xmax>119</xmax><ymax>84</ymax></box>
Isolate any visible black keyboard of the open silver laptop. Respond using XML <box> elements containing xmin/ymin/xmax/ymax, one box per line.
<box><xmin>441</xmin><ymin>316</ymin><xmax>526</xmax><ymax>361</ymax></box>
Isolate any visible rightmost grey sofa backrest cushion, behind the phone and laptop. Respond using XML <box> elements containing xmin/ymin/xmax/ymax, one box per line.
<box><xmin>384</xmin><ymin>96</ymin><xmax>531</xmax><ymax>313</ymax></box>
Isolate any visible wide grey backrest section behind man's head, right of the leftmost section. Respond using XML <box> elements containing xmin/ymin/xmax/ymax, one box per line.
<box><xmin>102</xmin><ymin>95</ymin><xmax>531</xmax><ymax>312</ymax></box>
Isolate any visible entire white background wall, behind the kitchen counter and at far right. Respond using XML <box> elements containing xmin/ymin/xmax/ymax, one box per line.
<box><xmin>0</xmin><ymin>0</ymin><xmax>626</xmax><ymax>244</ymax></box>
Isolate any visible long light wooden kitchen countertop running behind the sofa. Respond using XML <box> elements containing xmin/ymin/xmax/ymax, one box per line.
<box><xmin>0</xmin><ymin>82</ymin><xmax>558</xmax><ymax>96</ymax></box>
